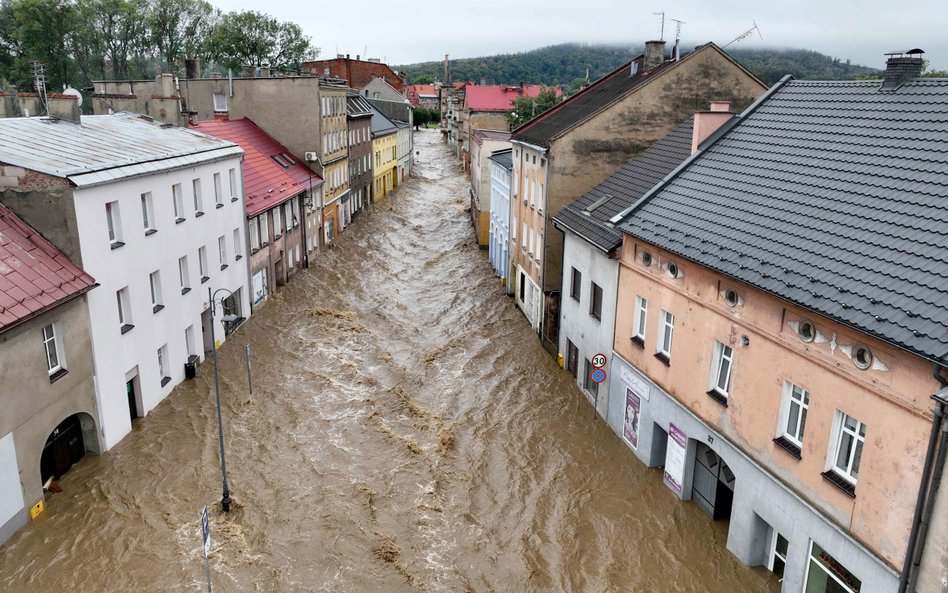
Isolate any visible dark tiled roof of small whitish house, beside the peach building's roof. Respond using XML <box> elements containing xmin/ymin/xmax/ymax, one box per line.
<box><xmin>553</xmin><ymin>118</ymin><xmax>694</xmax><ymax>253</ymax></box>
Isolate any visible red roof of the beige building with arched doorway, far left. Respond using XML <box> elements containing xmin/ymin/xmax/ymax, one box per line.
<box><xmin>0</xmin><ymin>204</ymin><xmax>95</xmax><ymax>332</ymax></box>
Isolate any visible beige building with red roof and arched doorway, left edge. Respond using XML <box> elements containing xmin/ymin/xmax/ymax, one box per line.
<box><xmin>0</xmin><ymin>204</ymin><xmax>102</xmax><ymax>544</ymax></box>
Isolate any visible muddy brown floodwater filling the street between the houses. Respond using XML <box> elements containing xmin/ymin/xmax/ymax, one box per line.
<box><xmin>0</xmin><ymin>131</ymin><xmax>773</xmax><ymax>593</ymax></box>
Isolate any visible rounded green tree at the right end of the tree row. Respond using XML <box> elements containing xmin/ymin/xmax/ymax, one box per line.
<box><xmin>208</xmin><ymin>10</ymin><xmax>319</xmax><ymax>71</ymax></box>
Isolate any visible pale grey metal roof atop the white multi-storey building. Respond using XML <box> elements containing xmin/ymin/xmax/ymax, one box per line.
<box><xmin>0</xmin><ymin>113</ymin><xmax>243</xmax><ymax>187</ymax></box>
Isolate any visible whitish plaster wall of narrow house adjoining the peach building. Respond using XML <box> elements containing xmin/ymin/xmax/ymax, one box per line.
<box><xmin>559</xmin><ymin>231</ymin><xmax>619</xmax><ymax>417</ymax></box>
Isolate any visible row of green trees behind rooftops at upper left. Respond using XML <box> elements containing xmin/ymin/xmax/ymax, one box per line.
<box><xmin>0</xmin><ymin>0</ymin><xmax>319</xmax><ymax>92</ymax></box>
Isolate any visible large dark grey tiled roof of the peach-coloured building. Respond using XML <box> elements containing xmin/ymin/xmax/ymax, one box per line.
<box><xmin>619</xmin><ymin>79</ymin><xmax>948</xmax><ymax>362</ymax></box>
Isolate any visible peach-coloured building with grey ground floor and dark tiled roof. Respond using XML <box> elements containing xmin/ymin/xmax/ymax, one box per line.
<box><xmin>607</xmin><ymin>53</ymin><xmax>948</xmax><ymax>593</ymax></box>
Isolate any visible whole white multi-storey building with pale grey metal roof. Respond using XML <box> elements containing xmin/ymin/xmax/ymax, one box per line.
<box><xmin>0</xmin><ymin>114</ymin><xmax>250</xmax><ymax>449</ymax></box>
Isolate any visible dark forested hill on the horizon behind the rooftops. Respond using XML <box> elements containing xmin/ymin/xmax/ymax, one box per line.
<box><xmin>395</xmin><ymin>43</ymin><xmax>881</xmax><ymax>88</ymax></box>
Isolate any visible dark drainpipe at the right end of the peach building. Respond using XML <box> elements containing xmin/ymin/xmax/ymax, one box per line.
<box><xmin>899</xmin><ymin>363</ymin><xmax>948</xmax><ymax>593</ymax></box>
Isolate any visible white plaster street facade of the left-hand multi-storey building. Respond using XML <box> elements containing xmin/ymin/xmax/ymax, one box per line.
<box><xmin>75</xmin><ymin>158</ymin><xmax>251</xmax><ymax>449</ymax></box>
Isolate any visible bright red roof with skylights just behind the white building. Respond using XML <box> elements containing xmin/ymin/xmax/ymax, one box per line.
<box><xmin>191</xmin><ymin>118</ymin><xmax>323</xmax><ymax>216</ymax></box>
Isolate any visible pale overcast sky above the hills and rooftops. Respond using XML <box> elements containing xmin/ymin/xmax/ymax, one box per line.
<box><xmin>217</xmin><ymin>0</ymin><xmax>948</xmax><ymax>70</ymax></box>
